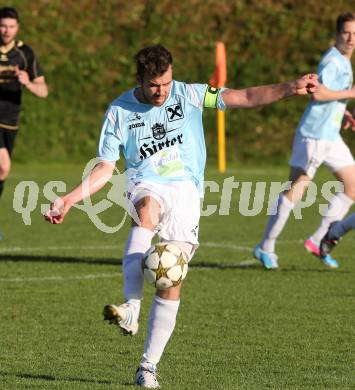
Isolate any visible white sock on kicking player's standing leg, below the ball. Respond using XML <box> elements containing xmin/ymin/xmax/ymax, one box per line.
<box><xmin>141</xmin><ymin>296</ymin><xmax>180</xmax><ymax>365</ymax></box>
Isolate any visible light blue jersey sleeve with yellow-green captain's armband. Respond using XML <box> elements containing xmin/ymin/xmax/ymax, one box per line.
<box><xmin>187</xmin><ymin>84</ymin><xmax>225</xmax><ymax>110</ymax></box>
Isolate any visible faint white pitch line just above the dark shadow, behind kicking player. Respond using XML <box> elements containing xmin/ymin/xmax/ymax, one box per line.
<box><xmin>0</xmin><ymin>240</ymin><xmax>302</xmax><ymax>254</ymax></box>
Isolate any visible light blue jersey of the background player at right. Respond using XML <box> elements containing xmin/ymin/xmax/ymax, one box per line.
<box><xmin>297</xmin><ymin>47</ymin><xmax>353</xmax><ymax>141</ymax></box>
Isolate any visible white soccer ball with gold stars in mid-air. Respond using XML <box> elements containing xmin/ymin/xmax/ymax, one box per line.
<box><xmin>142</xmin><ymin>242</ymin><xmax>188</xmax><ymax>290</ymax></box>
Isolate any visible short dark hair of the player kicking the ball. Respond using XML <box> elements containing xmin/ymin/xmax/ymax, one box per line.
<box><xmin>134</xmin><ymin>45</ymin><xmax>173</xmax><ymax>80</ymax></box>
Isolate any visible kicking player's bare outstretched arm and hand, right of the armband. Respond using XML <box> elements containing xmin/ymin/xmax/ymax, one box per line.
<box><xmin>222</xmin><ymin>74</ymin><xmax>318</xmax><ymax>108</ymax></box>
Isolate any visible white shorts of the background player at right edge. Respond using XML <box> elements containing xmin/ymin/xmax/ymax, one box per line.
<box><xmin>289</xmin><ymin>133</ymin><xmax>355</xmax><ymax>179</ymax></box>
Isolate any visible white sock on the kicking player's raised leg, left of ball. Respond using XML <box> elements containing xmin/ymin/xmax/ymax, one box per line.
<box><xmin>123</xmin><ymin>226</ymin><xmax>154</xmax><ymax>302</ymax></box>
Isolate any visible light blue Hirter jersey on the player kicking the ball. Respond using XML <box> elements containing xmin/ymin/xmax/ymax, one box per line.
<box><xmin>97</xmin><ymin>81</ymin><xmax>225</xmax><ymax>197</ymax></box>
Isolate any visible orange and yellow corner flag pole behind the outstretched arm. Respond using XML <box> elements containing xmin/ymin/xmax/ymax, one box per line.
<box><xmin>210</xmin><ymin>42</ymin><xmax>227</xmax><ymax>173</ymax></box>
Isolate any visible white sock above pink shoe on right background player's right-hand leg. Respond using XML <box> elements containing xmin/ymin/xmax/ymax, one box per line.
<box><xmin>309</xmin><ymin>192</ymin><xmax>354</xmax><ymax>246</ymax></box>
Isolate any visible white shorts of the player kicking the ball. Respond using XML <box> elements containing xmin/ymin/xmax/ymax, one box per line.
<box><xmin>127</xmin><ymin>180</ymin><xmax>201</xmax><ymax>254</ymax></box>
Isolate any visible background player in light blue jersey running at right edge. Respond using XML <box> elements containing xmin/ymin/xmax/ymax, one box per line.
<box><xmin>254</xmin><ymin>13</ymin><xmax>355</xmax><ymax>269</ymax></box>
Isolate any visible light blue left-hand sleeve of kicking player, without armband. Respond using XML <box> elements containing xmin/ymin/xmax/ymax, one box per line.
<box><xmin>96</xmin><ymin>107</ymin><xmax>122</xmax><ymax>162</ymax></box>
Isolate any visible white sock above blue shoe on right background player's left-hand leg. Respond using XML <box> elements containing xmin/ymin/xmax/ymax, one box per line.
<box><xmin>260</xmin><ymin>194</ymin><xmax>295</xmax><ymax>253</ymax></box>
